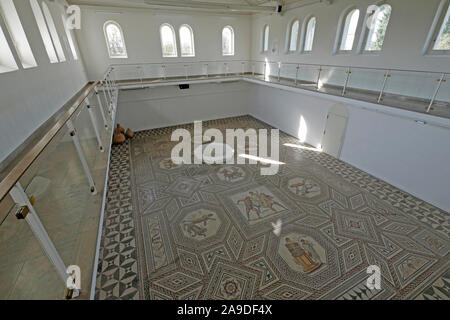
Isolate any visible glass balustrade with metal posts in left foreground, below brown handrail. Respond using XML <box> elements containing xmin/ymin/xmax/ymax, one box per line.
<box><xmin>0</xmin><ymin>75</ymin><xmax>117</xmax><ymax>299</ymax></box>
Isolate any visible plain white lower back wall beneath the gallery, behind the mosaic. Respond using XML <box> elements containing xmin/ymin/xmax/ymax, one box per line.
<box><xmin>116</xmin><ymin>81</ymin><xmax>250</xmax><ymax>131</ymax></box>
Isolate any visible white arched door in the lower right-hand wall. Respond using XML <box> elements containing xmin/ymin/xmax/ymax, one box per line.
<box><xmin>322</xmin><ymin>113</ymin><xmax>347</xmax><ymax>158</ymax></box>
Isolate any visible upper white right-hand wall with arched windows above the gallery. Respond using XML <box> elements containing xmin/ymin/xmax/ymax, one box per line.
<box><xmin>252</xmin><ymin>0</ymin><xmax>450</xmax><ymax>72</ymax></box>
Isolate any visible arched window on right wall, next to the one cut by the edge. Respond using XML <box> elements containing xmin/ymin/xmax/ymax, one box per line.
<box><xmin>365</xmin><ymin>4</ymin><xmax>392</xmax><ymax>51</ymax></box>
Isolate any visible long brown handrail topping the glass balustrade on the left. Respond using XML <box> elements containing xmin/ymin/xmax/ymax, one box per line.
<box><xmin>0</xmin><ymin>81</ymin><xmax>99</xmax><ymax>201</ymax></box>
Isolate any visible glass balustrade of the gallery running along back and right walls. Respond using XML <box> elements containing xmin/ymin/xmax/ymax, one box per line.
<box><xmin>110</xmin><ymin>60</ymin><xmax>450</xmax><ymax>118</ymax></box>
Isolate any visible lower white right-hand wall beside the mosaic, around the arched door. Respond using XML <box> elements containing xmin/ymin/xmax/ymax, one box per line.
<box><xmin>249</xmin><ymin>83</ymin><xmax>450</xmax><ymax>212</ymax></box>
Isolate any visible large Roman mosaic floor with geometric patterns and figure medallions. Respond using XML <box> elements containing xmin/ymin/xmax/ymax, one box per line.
<box><xmin>96</xmin><ymin>116</ymin><xmax>450</xmax><ymax>299</ymax></box>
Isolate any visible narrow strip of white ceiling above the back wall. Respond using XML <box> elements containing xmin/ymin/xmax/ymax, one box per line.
<box><xmin>67</xmin><ymin>0</ymin><xmax>304</xmax><ymax>13</ymax></box>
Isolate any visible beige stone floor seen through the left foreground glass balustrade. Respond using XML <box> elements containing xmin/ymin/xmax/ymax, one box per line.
<box><xmin>0</xmin><ymin>105</ymin><xmax>111</xmax><ymax>300</ymax></box>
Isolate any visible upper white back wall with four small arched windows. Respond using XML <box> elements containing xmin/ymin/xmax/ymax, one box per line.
<box><xmin>77</xmin><ymin>6</ymin><xmax>251</xmax><ymax>80</ymax></box>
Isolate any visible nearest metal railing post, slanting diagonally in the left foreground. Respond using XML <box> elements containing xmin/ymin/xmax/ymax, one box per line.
<box><xmin>9</xmin><ymin>182</ymin><xmax>80</xmax><ymax>298</ymax></box>
